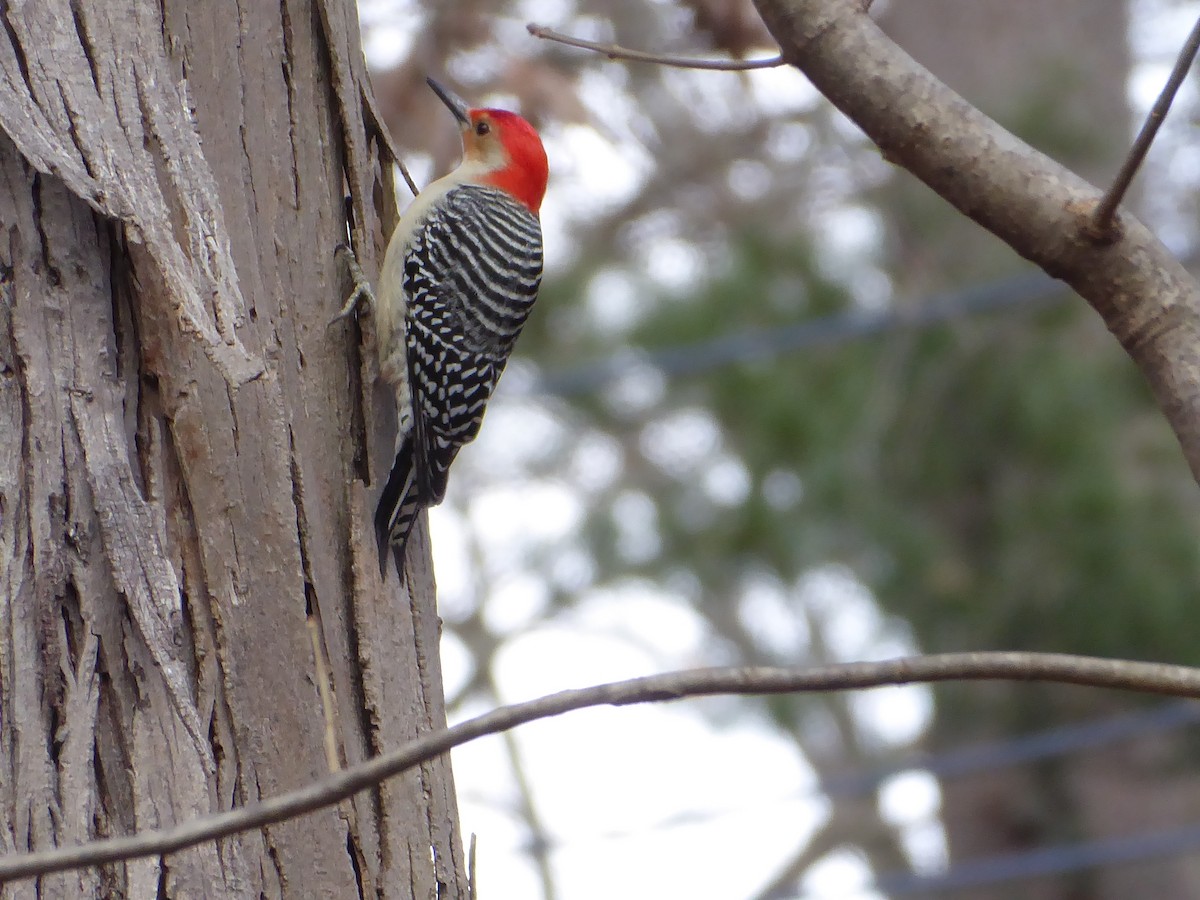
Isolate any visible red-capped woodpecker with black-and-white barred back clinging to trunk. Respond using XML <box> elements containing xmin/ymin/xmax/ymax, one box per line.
<box><xmin>347</xmin><ymin>78</ymin><xmax>547</xmax><ymax>575</ymax></box>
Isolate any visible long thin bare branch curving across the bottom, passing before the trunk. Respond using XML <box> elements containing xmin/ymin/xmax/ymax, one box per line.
<box><xmin>0</xmin><ymin>652</ymin><xmax>1200</xmax><ymax>883</ymax></box>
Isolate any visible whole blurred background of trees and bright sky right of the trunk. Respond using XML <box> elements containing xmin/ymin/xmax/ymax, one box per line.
<box><xmin>361</xmin><ymin>0</ymin><xmax>1200</xmax><ymax>900</ymax></box>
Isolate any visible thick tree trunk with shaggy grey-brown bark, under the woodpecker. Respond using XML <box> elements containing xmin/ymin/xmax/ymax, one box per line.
<box><xmin>0</xmin><ymin>0</ymin><xmax>466</xmax><ymax>900</ymax></box>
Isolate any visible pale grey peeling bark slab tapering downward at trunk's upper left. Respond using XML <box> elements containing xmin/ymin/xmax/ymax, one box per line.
<box><xmin>0</xmin><ymin>0</ymin><xmax>255</xmax><ymax>384</ymax></box>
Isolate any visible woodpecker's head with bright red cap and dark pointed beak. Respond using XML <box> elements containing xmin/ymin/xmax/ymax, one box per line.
<box><xmin>425</xmin><ymin>78</ymin><xmax>548</xmax><ymax>212</ymax></box>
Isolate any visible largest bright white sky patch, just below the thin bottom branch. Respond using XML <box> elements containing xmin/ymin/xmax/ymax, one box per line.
<box><xmin>463</xmin><ymin>707</ymin><xmax>826</xmax><ymax>900</ymax></box>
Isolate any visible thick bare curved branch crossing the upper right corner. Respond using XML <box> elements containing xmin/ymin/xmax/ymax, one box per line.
<box><xmin>755</xmin><ymin>0</ymin><xmax>1200</xmax><ymax>480</ymax></box>
